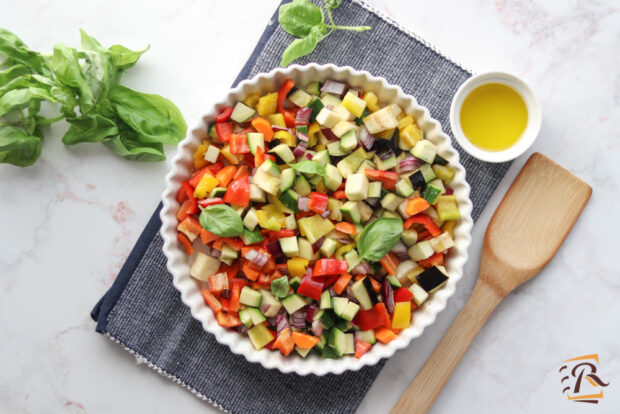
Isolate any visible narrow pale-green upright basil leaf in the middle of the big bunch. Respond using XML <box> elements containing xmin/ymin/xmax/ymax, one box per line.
<box><xmin>49</xmin><ymin>43</ymin><xmax>95</xmax><ymax>113</ymax></box>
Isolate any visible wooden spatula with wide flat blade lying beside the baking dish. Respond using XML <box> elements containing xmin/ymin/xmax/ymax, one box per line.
<box><xmin>392</xmin><ymin>153</ymin><xmax>592</xmax><ymax>414</ymax></box>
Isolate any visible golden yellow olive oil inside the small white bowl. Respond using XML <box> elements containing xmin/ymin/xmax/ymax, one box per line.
<box><xmin>461</xmin><ymin>83</ymin><xmax>527</xmax><ymax>151</ymax></box>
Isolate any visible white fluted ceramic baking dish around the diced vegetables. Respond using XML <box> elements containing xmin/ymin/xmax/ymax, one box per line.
<box><xmin>161</xmin><ymin>64</ymin><xmax>472</xmax><ymax>375</ymax></box>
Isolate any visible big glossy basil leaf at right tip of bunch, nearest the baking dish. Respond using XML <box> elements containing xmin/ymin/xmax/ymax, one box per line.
<box><xmin>109</xmin><ymin>85</ymin><xmax>187</xmax><ymax>145</ymax></box>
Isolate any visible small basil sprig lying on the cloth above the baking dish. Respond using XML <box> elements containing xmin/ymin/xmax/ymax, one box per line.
<box><xmin>278</xmin><ymin>0</ymin><xmax>371</xmax><ymax>66</ymax></box>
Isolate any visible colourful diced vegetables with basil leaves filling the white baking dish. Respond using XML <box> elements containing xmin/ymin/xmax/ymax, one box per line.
<box><xmin>177</xmin><ymin>79</ymin><xmax>460</xmax><ymax>358</ymax></box>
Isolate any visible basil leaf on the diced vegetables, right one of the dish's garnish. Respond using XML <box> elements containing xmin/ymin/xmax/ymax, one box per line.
<box><xmin>357</xmin><ymin>217</ymin><xmax>403</xmax><ymax>262</ymax></box>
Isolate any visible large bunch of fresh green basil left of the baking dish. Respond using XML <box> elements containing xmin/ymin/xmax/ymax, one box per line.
<box><xmin>0</xmin><ymin>28</ymin><xmax>187</xmax><ymax>167</ymax></box>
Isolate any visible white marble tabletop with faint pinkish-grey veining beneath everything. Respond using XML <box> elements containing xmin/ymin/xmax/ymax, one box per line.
<box><xmin>0</xmin><ymin>0</ymin><xmax>620</xmax><ymax>414</ymax></box>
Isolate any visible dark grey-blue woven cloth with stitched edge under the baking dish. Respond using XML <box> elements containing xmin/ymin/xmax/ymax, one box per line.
<box><xmin>92</xmin><ymin>0</ymin><xmax>508</xmax><ymax>413</ymax></box>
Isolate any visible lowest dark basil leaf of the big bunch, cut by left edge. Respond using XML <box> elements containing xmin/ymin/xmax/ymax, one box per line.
<box><xmin>0</xmin><ymin>126</ymin><xmax>43</xmax><ymax>167</ymax></box>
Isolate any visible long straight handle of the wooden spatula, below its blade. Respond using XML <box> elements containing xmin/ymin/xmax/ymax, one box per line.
<box><xmin>392</xmin><ymin>278</ymin><xmax>502</xmax><ymax>414</ymax></box>
